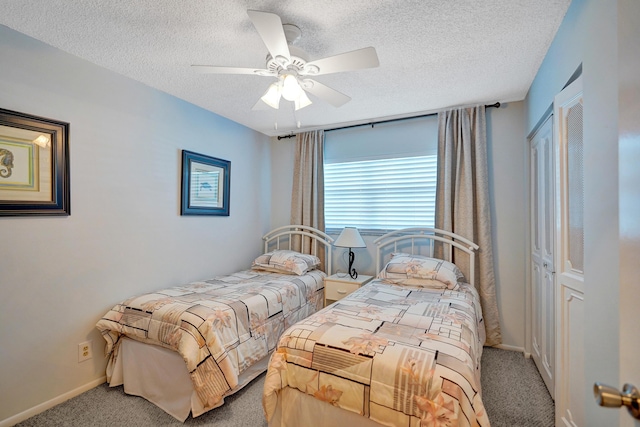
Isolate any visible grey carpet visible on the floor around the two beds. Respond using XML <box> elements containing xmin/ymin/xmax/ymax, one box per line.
<box><xmin>18</xmin><ymin>347</ymin><xmax>554</xmax><ymax>427</ymax></box>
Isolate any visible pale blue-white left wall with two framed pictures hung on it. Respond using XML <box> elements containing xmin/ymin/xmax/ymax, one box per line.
<box><xmin>0</xmin><ymin>26</ymin><xmax>271</xmax><ymax>423</ymax></box>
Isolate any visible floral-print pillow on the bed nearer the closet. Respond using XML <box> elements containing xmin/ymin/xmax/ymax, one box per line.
<box><xmin>378</xmin><ymin>252</ymin><xmax>464</xmax><ymax>289</ymax></box>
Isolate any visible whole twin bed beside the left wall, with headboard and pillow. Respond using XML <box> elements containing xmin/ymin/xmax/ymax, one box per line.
<box><xmin>96</xmin><ymin>226</ymin><xmax>333</xmax><ymax>421</ymax></box>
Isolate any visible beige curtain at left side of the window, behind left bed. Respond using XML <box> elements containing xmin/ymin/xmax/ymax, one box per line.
<box><xmin>291</xmin><ymin>130</ymin><xmax>325</xmax><ymax>266</ymax></box>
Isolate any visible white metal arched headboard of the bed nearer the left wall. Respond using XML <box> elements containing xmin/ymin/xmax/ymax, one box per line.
<box><xmin>262</xmin><ymin>225</ymin><xmax>333</xmax><ymax>275</ymax></box>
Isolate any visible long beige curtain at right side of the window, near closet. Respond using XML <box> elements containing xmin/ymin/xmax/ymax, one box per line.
<box><xmin>436</xmin><ymin>106</ymin><xmax>502</xmax><ymax>345</ymax></box>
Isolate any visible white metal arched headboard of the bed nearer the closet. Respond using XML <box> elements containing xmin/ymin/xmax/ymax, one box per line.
<box><xmin>374</xmin><ymin>228</ymin><xmax>479</xmax><ymax>285</ymax></box>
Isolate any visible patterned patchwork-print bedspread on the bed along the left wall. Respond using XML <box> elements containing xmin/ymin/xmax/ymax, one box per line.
<box><xmin>96</xmin><ymin>270</ymin><xmax>325</xmax><ymax>409</ymax></box>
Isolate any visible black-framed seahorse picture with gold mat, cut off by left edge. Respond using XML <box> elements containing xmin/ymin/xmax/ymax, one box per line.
<box><xmin>0</xmin><ymin>108</ymin><xmax>71</xmax><ymax>216</ymax></box>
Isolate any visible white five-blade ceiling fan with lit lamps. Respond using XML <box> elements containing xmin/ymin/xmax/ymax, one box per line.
<box><xmin>192</xmin><ymin>10</ymin><xmax>380</xmax><ymax>110</ymax></box>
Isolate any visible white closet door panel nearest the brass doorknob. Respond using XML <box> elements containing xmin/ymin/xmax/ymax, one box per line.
<box><xmin>554</xmin><ymin>78</ymin><xmax>586</xmax><ymax>426</ymax></box>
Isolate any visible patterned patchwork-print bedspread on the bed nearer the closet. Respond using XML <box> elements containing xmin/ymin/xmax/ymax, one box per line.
<box><xmin>263</xmin><ymin>280</ymin><xmax>489</xmax><ymax>427</ymax></box>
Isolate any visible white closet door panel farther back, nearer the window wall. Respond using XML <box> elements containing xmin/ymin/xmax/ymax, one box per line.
<box><xmin>530</xmin><ymin>114</ymin><xmax>555</xmax><ymax>396</ymax></box>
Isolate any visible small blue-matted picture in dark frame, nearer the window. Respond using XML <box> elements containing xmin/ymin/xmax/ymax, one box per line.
<box><xmin>180</xmin><ymin>150</ymin><xmax>231</xmax><ymax>216</ymax></box>
